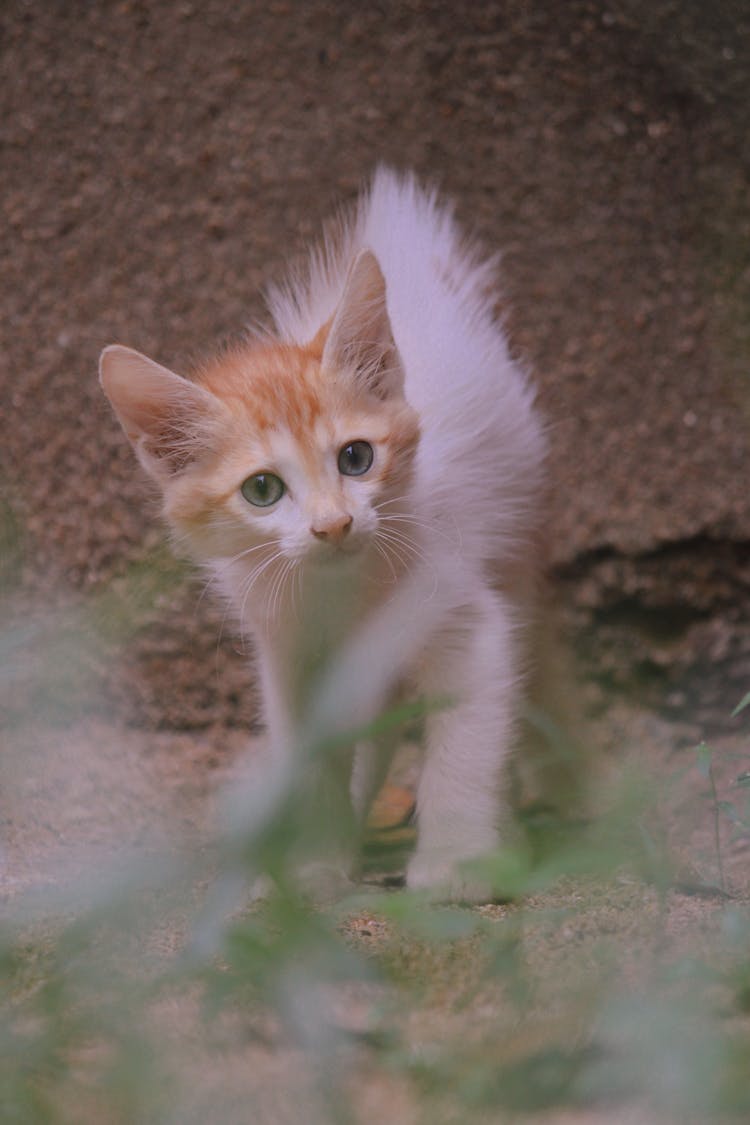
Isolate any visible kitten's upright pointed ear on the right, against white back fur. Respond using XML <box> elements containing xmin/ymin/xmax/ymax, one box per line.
<box><xmin>322</xmin><ymin>250</ymin><xmax>404</xmax><ymax>398</ymax></box>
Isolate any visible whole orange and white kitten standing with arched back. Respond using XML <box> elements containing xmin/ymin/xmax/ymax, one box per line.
<box><xmin>100</xmin><ymin>169</ymin><xmax>544</xmax><ymax>900</ymax></box>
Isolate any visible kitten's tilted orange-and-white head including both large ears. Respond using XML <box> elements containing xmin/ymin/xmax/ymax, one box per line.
<box><xmin>100</xmin><ymin>251</ymin><xmax>418</xmax><ymax>585</ymax></box>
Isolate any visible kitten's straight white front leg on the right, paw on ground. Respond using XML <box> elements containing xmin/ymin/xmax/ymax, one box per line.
<box><xmin>406</xmin><ymin>591</ymin><xmax>518</xmax><ymax>902</ymax></box>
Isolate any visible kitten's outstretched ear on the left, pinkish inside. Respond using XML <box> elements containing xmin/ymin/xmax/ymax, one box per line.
<box><xmin>99</xmin><ymin>344</ymin><xmax>223</xmax><ymax>482</ymax></box>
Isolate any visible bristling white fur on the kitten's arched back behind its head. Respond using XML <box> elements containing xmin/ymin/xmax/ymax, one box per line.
<box><xmin>269</xmin><ymin>168</ymin><xmax>545</xmax><ymax>571</ymax></box>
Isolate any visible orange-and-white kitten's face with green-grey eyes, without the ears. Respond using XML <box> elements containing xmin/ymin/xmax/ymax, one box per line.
<box><xmin>164</xmin><ymin>348</ymin><xmax>418</xmax><ymax>566</ymax></box>
